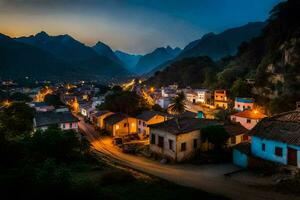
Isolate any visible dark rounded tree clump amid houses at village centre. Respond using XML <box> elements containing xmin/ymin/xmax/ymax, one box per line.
<box><xmin>100</xmin><ymin>91</ymin><xmax>149</xmax><ymax>116</ymax></box>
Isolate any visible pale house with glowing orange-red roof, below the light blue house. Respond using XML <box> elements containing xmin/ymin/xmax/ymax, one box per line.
<box><xmin>230</xmin><ymin>110</ymin><xmax>267</xmax><ymax>130</ymax></box>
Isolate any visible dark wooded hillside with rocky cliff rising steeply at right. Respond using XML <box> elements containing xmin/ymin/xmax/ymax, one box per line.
<box><xmin>148</xmin><ymin>0</ymin><xmax>300</xmax><ymax>114</ymax></box>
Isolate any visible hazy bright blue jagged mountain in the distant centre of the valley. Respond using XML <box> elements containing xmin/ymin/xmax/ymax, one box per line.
<box><xmin>134</xmin><ymin>46</ymin><xmax>181</xmax><ymax>74</ymax></box>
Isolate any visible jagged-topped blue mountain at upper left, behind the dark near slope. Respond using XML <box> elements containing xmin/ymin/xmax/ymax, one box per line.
<box><xmin>15</xmin><ymin>31</ymin><xmax>97</xmax><ymax>61</ymax></box>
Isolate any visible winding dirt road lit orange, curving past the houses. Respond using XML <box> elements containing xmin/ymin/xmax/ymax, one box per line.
<box><xmin>79</xmin><ymin>117</ymin><xmax>300</xmax><ymax>200</ymax></box>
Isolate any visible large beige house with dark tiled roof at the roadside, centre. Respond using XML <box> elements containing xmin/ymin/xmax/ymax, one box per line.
<box><xmin>150</xmin><ymin>117</ymin><xmax>218</xmax><ymax>162</ymax></box>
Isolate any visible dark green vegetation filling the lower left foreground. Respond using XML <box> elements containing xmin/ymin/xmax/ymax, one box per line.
<box><xmin>0</xmin><ymin>103</ymin><xmax>223</xmax><ymax>200</ymax></box>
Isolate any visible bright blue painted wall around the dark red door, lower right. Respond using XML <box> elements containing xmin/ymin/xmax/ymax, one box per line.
<box><xmin>251</xmin><ymin>136</ymin><xmax>300</xmax><ymax>167</ymax></box>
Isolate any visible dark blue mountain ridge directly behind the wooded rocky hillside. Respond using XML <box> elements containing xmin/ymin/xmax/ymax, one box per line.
<box><xmin>149</xmin><ymin>22</ymin><xmax>266</xmax><ymax>75</ymax></box>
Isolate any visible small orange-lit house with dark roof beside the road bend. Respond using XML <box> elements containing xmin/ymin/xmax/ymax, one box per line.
<box><xmin>104</xmin><ymin>113</ymin><xmax>137</xmax><ymax>137</ymax></box>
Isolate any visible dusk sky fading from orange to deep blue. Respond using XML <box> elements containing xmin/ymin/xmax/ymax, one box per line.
<box><xmin>0</xmin><ymin>0</ymin><xmax>281</xmax><ymax>54</ymax></box>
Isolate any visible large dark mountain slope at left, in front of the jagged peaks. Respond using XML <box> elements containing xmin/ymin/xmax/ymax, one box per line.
<box><xmin>0</xmin><ymin>33</ymin><xmax>130</xmax><ymax>80</ymax></box>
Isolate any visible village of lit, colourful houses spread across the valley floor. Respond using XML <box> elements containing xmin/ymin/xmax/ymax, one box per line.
<box><xmin>2</xmin><ymin>80</ymin><xmax>300</xmax><ymax>172</ymax></box>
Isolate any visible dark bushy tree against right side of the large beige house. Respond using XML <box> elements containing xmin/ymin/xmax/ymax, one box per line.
<box><xmin>201</xmin><ymin>125</ymin><xmax>229</xmax><ymax>151</ymax></box>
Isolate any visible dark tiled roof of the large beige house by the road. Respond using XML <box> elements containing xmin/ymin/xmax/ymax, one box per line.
<box><xmin>150</xmin><ymin>117</ymin><xmax>220</xmax><ymax>135</ymax></box>
